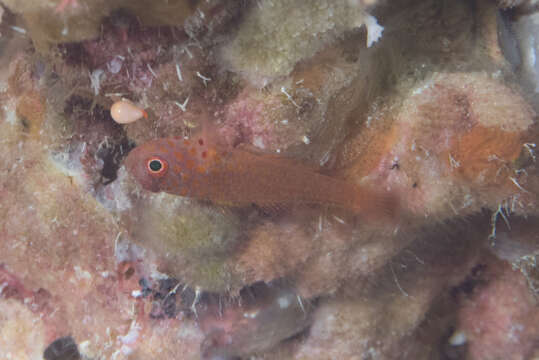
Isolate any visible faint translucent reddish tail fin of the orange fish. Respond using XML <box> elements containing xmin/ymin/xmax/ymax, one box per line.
<box><xmin>355</xmin><ymin>187</ymin><xmax>400</xmax><ymax>221</ymax></box>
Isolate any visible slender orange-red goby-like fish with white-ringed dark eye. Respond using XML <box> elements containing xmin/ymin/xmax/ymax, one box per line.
<box><xmin>126</xmin><ymin>138</ymin><xmax>395</xmax><ymax>215</ymax></box>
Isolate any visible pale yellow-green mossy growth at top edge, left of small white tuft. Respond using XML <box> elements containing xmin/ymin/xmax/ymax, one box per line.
<box><xmin>222</xmin><ymin>0</ymin><xmax>365</xmax><ymax>86</ymax></box>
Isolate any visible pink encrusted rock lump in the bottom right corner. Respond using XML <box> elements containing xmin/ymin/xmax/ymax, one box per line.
<box><xmin>458</xmin><ymin>256</ymin><xmax>539</xmax><ymax>359</ymax></box>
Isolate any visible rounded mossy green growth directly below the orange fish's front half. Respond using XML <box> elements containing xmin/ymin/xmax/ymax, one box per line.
<box><xmin>130</xmin><ymin>193</ymin><xmax>242</xmax><ymax>292</ymax></box>
